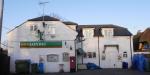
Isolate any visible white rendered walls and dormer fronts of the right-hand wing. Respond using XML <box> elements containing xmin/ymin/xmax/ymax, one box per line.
<box><xmin>78</xmin><ymin>28</ymin><xmax>133</xmax><ymax>68</ymax></box>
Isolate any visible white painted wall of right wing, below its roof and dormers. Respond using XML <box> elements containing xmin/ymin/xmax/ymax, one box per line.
<box><xmin>79</xmin><ymin>36</ymin><xmax>133</xmax><ymax>68</ymax></box>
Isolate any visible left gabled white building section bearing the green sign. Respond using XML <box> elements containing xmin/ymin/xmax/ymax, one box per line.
<box><xmin>7</xmin><ymin>16</ymin><xmax>77</xmax><ymax>73</ymax></box>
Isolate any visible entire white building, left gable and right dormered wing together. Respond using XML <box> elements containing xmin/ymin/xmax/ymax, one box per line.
<box><xmin>7</xmin><ymin>16</ymin><xmax>133</xmax><ymax>73</ymax></box>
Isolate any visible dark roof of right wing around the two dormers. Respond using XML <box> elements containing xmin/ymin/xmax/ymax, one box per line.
<box><xmin>77</xmin><ymin>24</ymin><xmax>132</xmax><ymax>37</ymax></box>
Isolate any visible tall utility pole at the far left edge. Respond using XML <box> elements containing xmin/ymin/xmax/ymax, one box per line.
<box><xmin>0</xmin><ymin>0</ymin><xmax>4</xmax><ymax>47</ymax></box>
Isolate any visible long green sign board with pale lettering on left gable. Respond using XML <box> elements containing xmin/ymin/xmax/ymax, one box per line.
<box><xmin>20</xmin><ymin>41</ymin><xmax>62</xmax><ymax>48</ymax></box>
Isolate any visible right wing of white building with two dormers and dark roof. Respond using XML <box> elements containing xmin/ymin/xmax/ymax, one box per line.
<box><xmin>77</xmin><ymin>24</ymin><xmax>133</xmax><ymax>68</ymax></box>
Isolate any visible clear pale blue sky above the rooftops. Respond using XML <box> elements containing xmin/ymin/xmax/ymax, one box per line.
<box><xmin>2</xmin><ymin>0</ymin><xmax>150</xmax><ymax>41</ymax></box>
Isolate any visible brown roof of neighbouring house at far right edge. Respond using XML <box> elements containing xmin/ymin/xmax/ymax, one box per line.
<box><xmin>140</xmin><ymin>28</ymin><xmax>150</xmax><ymax>43</ymax></box>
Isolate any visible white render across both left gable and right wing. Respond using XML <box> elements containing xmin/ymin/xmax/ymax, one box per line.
<box><xmin>7</xmin><ymin>16</ymin><xmax>133</xmax><ymax>73</ymax></box>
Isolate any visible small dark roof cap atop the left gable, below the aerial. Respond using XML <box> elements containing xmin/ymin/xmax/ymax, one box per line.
<box><xmin>28</xmin><ymin>16</ymin><xmax>60</xmax><ymax>21</ymax></box>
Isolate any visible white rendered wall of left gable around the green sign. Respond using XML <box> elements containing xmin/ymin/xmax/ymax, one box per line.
<box><xmin>7</xmin><ymin>21</ymin><xmax>77</xmax><ymax>73</ymax></box>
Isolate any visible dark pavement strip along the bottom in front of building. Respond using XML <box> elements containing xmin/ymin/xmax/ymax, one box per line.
<box><xmin>11</xmin><ymin>69</ymin><xmax>150</xmax><ymax>75</ymax></box>
